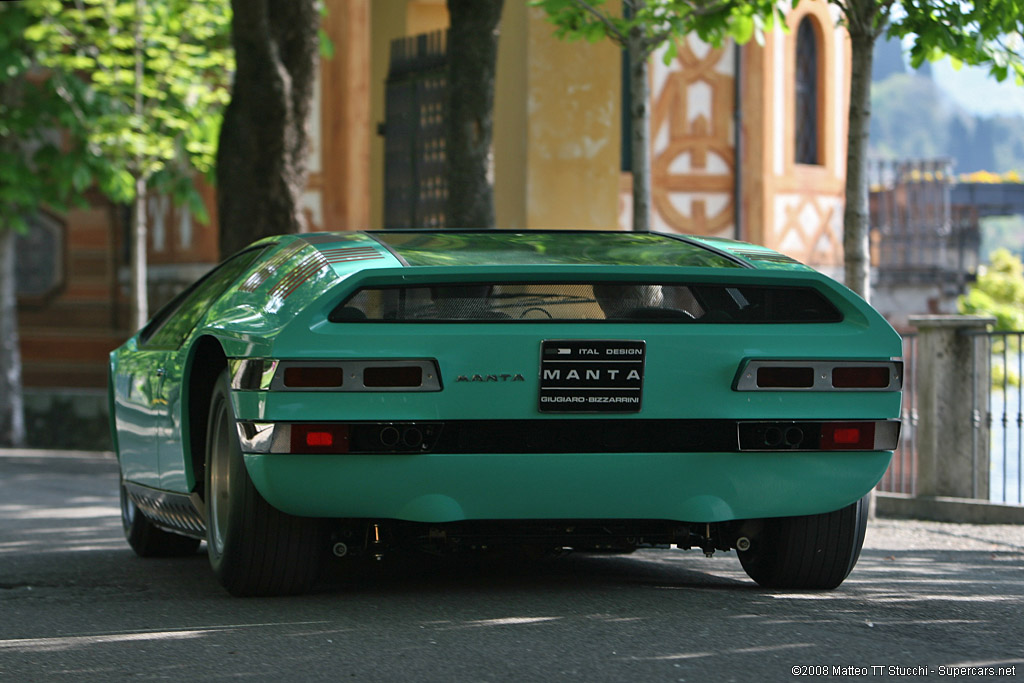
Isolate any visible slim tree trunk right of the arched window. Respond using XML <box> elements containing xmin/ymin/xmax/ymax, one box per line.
<box><xmin>843</xmin><ymin>23</ymin><xmax>874</xmax><ymax>301</ymax></box>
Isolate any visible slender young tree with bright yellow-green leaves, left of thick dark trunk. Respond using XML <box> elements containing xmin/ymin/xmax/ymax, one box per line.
<box><xmin>25</xmin><ymin>0</ymin><xmax>233</xmax><ymax>327</ymax></box>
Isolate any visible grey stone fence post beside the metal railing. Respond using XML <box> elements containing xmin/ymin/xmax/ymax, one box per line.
<box><xmin>909</xmin><ymin>315</ymin><xmax>995</xmax><ymax>499</ymax></box>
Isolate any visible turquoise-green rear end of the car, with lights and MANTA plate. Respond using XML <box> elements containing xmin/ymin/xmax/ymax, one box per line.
<box><xmin>230</xmin><ymin>263</ymin><xmax>902</xmax><ymax>525</ymax></box>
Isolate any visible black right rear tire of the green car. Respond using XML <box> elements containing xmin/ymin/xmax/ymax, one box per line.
<box><xmin>738</xmin><ymin>496</ymin><xmax>868</xmax><ymax>590</ymax></box>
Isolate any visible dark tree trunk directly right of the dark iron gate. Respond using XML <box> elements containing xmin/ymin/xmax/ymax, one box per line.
<box><xmin>444</xmin><ymin>0</ymin><xmax>503</xmax><ymax>227</ymax></box>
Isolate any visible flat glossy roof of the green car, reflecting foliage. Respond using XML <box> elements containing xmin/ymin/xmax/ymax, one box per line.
<box><xmin>366</xmin><ymin>229</ymin><xmax>750</xmax><ymax>268</ymax></box>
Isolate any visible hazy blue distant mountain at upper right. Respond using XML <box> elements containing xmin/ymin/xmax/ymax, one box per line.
<box><xmin>870</xmin><ymin>35</ymin><xmax>1024</xmax><ymax>173</ymax></box>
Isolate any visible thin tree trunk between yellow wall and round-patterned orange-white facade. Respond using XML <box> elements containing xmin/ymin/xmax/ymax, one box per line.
<box><xmin>627</xmin><ymin>28</ymin><xmax>650</xmax><ymax>230</ymax></box>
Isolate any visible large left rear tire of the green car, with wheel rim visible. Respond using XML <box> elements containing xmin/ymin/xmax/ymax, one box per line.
<box><xmin>206</xmin><ymin>370</ymin><xmax>327</xmax><ymax>596</ymax></box>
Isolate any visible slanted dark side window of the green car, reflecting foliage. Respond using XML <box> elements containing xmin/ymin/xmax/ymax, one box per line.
<box><xmin>139</xmin><ymin>249</ymin><xmax>263</xmax><ymax>348</ymax></box>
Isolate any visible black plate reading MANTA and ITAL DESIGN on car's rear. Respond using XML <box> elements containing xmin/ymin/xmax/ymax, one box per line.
<box><xmin>538</xmin><ymin>339</ymin><xmax>647</xmax><ymax>413</ymax></box>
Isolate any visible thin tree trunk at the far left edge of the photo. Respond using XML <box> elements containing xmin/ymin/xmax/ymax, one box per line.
<box><xmin>0</xmin><ymin>227</ymin><xmax>25</xmax><ymax>447</ymax></box>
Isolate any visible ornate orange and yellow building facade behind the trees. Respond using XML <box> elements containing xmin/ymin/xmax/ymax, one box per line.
<box><xmin>19</xmin><ymin>0</ymin><xmax>850</xmax><ymax>395</ymax></box>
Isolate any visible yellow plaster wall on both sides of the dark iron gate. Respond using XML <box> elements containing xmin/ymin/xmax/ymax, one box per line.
<box><xmin>369</xmin><ymin>0</ymin><xmax>621</xmax><ymax>228</ymax></box>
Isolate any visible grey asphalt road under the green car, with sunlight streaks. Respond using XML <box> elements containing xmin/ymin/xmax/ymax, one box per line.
<box><xmin>0</xmin><ymin>453</ymin><xmax>1024</xmax><ymax>681</ymax></box>
